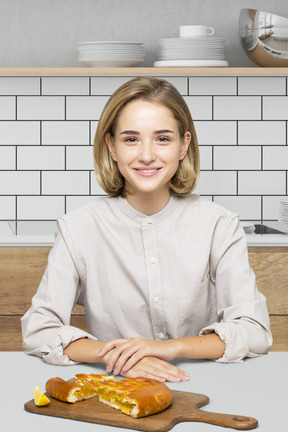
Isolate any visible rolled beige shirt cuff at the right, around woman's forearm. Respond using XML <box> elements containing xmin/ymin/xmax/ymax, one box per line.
<box><xmin>200</xmin><ymin>323</ymin><xmax>249</xmax><ymax>363</ymax></box>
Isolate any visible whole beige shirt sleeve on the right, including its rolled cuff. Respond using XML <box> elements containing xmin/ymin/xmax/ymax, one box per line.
<box><xmin>200</xmin><ymin>216</ymin><xmax>272</xmax><ymax>363</ymax></box>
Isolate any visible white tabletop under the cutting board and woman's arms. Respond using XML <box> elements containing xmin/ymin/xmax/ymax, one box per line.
<box><xmin>0</xmin><ymin>352</ymin><xmax>288</xmax><ymax>432</ymax></box>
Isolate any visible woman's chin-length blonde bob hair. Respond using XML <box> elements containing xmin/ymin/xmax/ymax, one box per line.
<box><xmin>94</xmin><ymin>77</ymin><xmax>200</xmax><ymax>197</ymax></box>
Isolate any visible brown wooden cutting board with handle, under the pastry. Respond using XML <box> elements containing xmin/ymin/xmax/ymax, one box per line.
<box><xmin>24</xmin><ymin>390</ymin><xmax>258</xmax><ymax>432</ymax></box>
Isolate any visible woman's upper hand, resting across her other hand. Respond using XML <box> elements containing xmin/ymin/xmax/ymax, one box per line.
<box><xmin>97</xmin><ymin>338</ymin><xmax>181</xmax><ymax>375</ymax></box>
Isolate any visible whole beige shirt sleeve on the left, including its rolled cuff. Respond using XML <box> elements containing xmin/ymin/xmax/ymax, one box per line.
<box><xmin>21</xmin><ymin>222</ymin><xmax>96</xmax><ymax>365</ymax></box>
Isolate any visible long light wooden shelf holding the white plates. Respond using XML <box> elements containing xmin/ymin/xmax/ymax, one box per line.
<box><xmin>0</xmin><ymin>67</ymin><xmax>288</xmax><ymax>76</ymax></box>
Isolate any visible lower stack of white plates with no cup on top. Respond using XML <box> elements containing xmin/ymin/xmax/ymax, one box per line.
<box><xmin>78</xmin><ymin>41</ymin><xmax>145</xmax><ymax>67</ymax></box>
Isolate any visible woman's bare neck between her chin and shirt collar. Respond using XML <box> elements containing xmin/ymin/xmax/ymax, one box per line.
<box><xmin>127</xmin><ymin>192</ymin><xmax>170</xmax><ymax>216</ymax></box>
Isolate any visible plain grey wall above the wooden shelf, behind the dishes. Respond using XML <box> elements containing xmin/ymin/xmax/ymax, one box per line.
<box><xmin>0</xmin><ymin>0</ymin><xmax>288</xmax><ymax>67</ymax></box>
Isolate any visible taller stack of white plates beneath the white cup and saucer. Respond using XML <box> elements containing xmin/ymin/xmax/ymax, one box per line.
<box><xmin>154</xmin><ymin>36</ymin><xmax>228</xmax><ymax>67</ymax></box>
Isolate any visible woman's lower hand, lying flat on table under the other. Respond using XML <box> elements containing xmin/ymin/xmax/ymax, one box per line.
<box><xmin>121</xmin><ymin>357</ymin><xmax>189</xmax><ymax>382</ymax></box>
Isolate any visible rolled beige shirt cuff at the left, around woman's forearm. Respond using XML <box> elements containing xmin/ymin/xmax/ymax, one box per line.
<box><xmin>41</xmin><ymin>325</ymin><xmax>97</xmax><ymax>366</ymax></box>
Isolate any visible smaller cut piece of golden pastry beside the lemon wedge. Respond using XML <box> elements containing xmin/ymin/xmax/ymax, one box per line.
<box><xmin>45</xmin><ymin>377</ymin><xmax>97</xmax><ymax>403</ymax></box>
